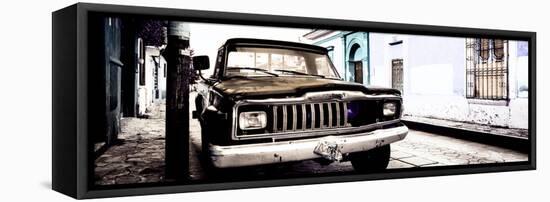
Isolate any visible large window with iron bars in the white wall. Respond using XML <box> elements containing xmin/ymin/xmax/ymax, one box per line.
<box><xmin>466</xmin><ymin>38</ymin><xmax>508</xmax><ymax>100</ymax></box>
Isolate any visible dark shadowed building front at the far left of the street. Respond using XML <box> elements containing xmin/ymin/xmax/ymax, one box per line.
<box><xmin>89</xmin><ymin>18</ymin><xmax>124</xmax><ymax>145</ymax></box>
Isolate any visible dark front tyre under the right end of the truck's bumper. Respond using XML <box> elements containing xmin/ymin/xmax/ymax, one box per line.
<box><xmin>349</xmin><ymin>145</ymin><xmax>390</xmax><ymax>173</ymax></box>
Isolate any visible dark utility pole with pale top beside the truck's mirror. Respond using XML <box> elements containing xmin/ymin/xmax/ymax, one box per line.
<box><xmin>165</xmin><ymin>21</ymin><xmax>191</xmax><ymax>182</ymax></box>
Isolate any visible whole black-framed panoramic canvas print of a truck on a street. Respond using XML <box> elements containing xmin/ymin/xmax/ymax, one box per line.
<box><xmin>52</xmin><ymin>3</ymin><xmax>536</xmax><ymax>199</ymax></box>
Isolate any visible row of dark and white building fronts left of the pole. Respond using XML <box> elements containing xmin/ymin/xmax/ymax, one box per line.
<box><xmin>89</xmin><ymin>17</ymin><xmax>167</xmax><ymax>150</ymax></box>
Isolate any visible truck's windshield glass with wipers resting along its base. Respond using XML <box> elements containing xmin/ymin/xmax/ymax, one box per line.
<box><xmin>225</xmin><ymin>47</ymin><xmax>339</xmax><ymax>79</ymax></box>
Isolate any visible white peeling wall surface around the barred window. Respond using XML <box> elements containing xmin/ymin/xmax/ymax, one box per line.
<box><xmin>370</xmin><ymin>33</ymin><xmax>528</xmax><ymax>128</ymax></box>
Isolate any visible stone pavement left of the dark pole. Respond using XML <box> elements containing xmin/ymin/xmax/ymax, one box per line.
<box><xmin>94</xmin><ymin>103</ymin><xmax>165</xmax><ymax>185</ymax></box>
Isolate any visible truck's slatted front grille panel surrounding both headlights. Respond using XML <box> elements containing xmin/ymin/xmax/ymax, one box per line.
<box><xmin>236</xmin><ymin>100</ymin><xmax>401</xmax><ymax>136</ymax></box>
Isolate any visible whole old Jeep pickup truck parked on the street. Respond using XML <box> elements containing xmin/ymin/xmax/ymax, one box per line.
<box><xmin>193</xmin><ymin>38</ymin><xmax>408</xmax><ymax>172</ymax></box>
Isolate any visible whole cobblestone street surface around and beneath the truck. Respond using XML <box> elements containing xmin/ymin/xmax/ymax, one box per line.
<box><xmin>95</xmin><ymin>94</ymin><xmax>528</xmax><ymax>184</ymax></box>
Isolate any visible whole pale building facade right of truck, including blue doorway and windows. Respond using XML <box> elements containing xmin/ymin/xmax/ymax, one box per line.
<box><xmin>303</xmin><ymin>30</ymin><xmax>528</xmax><ymax>129</ymax></box>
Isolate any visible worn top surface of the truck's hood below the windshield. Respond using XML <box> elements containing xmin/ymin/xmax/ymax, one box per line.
<box><xmin>214</xmin><ymin>76</ymin><xmax>401</xmax><ymax>99</ymax></box>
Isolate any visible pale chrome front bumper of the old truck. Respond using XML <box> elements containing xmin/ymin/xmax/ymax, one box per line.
<box><xmin>210</xmin><ymin>125</ymin><xmax>409</xmax><ymax>168</ymax></box>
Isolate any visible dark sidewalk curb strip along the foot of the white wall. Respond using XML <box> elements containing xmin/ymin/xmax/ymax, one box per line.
<box><xmin>401</xmin><ymin>120</ymin><xmax>531</xmax><ymax>152</ymax></box>
